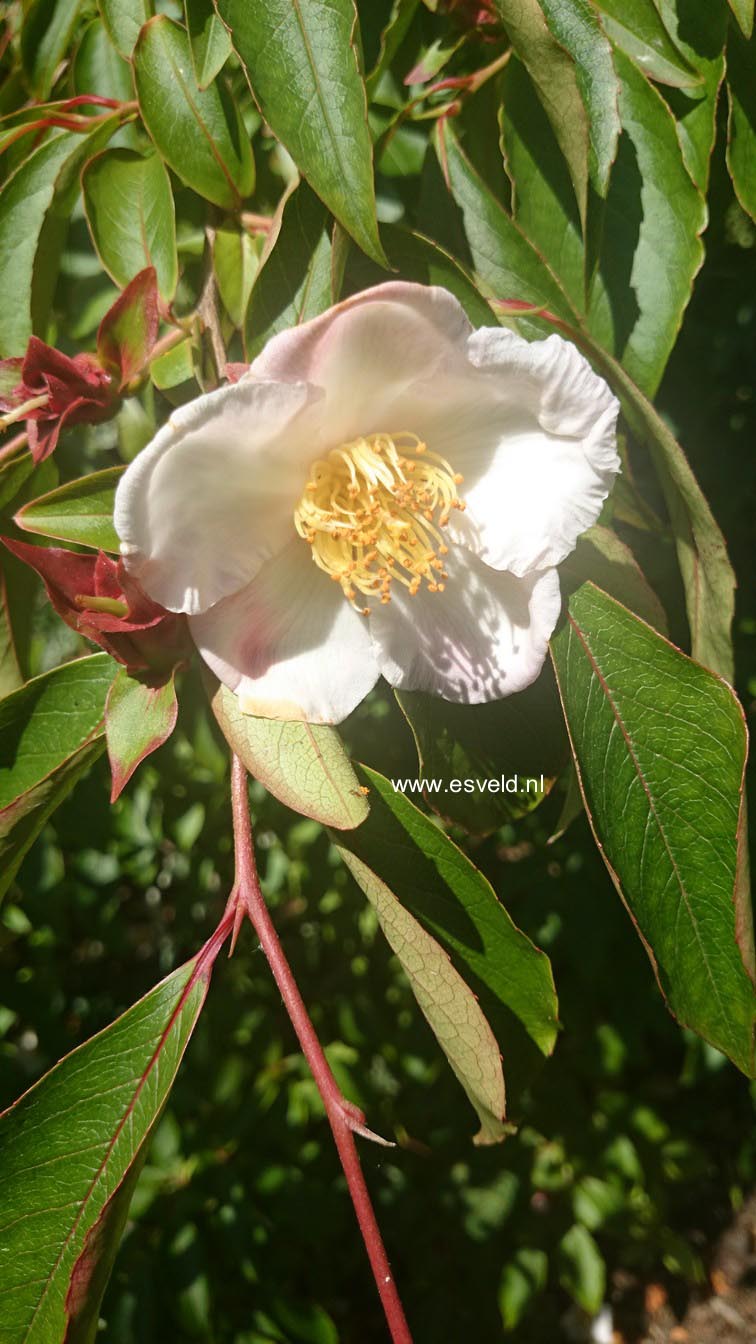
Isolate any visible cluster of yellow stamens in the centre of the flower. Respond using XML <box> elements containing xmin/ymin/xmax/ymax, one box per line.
<box><xmin>295</xmin><ymin>431</ymin><xmax>464</xmax><ymax>616</ymax></box>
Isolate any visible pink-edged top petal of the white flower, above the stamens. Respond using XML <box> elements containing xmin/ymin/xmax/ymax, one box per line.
<box><xmin>250</xmin><ymin>281</ymin><xmax>471</xmax><ymax>448</ymax></box>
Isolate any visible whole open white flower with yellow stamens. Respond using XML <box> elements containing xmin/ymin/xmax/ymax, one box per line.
<box><xmin>116</xmin><ymin>282</ymin><xmax>619</xmax><ymax>723</ymax></box>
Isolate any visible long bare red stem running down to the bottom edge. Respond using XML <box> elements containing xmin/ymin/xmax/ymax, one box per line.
<box><xmin>231</xmin><ymin>755</ymin><xmax>412</xmax><ymax>1344</ymax></box>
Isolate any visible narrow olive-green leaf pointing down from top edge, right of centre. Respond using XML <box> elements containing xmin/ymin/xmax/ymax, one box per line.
<box><xmin>495</xmin><ymin>0</ymin><xmax>591</xmax><ymax>222</ymax></box>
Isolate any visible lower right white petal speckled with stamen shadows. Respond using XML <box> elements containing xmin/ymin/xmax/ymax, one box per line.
<box><xmin>370</xmin><ymin>548</ymin><xmax>561</xmax><ymax>704</ymax></box>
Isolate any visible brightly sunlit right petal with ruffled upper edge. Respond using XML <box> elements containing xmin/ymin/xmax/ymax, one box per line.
<box><xmin>433</xmin><ymin>328</ymin><xmax>620</xmax><ymax>575</ymax></box>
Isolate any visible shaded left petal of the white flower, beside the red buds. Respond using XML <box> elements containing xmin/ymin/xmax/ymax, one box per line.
<box><xmin>114</xmin><ymin>380</ymin><xmax>322</xmax><ymax>614</ymax></box>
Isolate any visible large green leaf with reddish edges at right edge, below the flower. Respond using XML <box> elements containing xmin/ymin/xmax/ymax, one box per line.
<box><xmin>552</xmin><ymin>583</ymin><xmax>756</xmax><ymax>1074</ymax></box>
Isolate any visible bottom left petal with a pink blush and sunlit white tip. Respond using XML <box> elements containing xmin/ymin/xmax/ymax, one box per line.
<box><xmin>190</xmin><ymin>538</ymin><xmax>379</xmax><ymax>723</ymax></box>
